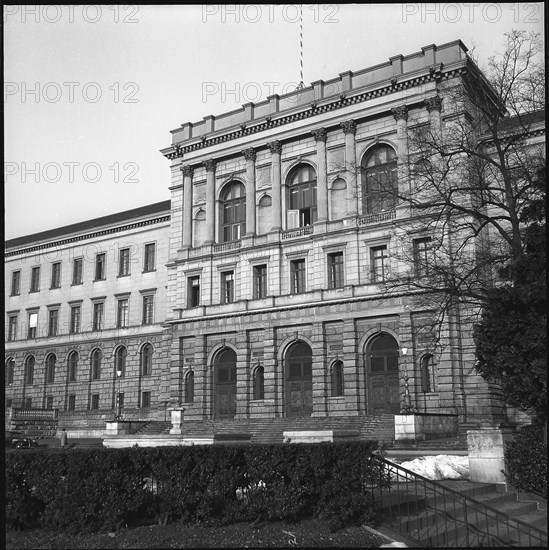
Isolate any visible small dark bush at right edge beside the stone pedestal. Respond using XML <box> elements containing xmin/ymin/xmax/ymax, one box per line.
<box><xmin>504</xmin><ymin>426</ymin><xmax>547</xmax><ymax>498</ymax></box>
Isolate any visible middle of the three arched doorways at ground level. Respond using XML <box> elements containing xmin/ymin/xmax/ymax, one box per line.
<box><xmin>285</xmin><ymin>342</ymin><xmax>313</xmax><ymax>417</ymax></box>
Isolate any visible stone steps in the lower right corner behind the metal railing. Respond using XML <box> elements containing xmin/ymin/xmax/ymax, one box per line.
<box><xmin>380</xmin><ymin>480</ymin><xmax>547</xmax><ymax>547</ymax></box>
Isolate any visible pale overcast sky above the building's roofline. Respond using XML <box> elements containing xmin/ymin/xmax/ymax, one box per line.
<box><xmin>4</xmin><ymin>3</ymin><xmax>544</xmax><ymax>239</ymax></box>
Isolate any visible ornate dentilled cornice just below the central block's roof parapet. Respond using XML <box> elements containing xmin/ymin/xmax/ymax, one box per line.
<box><xmin>164</xmin><ymin>64</ymin><xmax>468</xmax><ymax>160</ymax></box>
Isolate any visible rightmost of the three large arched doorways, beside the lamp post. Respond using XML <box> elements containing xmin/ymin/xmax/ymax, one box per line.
<box><xmin>366</xmin><ymin>334</ymin><xmax>400</xmax><ymax>414</ymax></box>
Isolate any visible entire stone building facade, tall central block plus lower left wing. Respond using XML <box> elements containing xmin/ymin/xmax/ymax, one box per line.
<box><xmin>5</xmin><ymin>41</ymin><xmax>540</xmax><ymax>436</ymax></box>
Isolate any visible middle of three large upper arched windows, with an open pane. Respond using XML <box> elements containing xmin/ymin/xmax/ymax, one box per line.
<box><xmin>288</xmin><ymin>164</ymin><xmax>316</xmax><ymax>229</ymax></box>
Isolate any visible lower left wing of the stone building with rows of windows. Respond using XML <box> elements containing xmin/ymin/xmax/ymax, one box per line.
<box><xmin>5</xmin><ymin>201</ymin><xmax>170</xmax><ymax>427</ymax></box>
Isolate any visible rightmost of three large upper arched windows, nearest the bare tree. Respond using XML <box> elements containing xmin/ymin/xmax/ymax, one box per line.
<box><xmin>362</xmin><ymin>145</ymin><xmax>398</xmax><ymax>214</ymax></box>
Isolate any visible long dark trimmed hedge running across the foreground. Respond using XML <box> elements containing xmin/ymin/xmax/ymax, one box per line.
<box><xmin>6</xmin><ymin>442</ymin><xmax>383</xmax><ymax>533</ymax></box>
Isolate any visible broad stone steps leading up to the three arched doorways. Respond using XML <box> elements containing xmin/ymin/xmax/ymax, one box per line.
<box><xmin>130</xmin><ymin>414</ymin><xmax>395</xmax><ymax>443</ymax></box>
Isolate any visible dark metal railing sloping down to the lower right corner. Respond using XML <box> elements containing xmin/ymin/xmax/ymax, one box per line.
<box><xmin>375</xmin><ymin>457</ymin><xmax>547</xmax><ymax>548</ymax></box>
